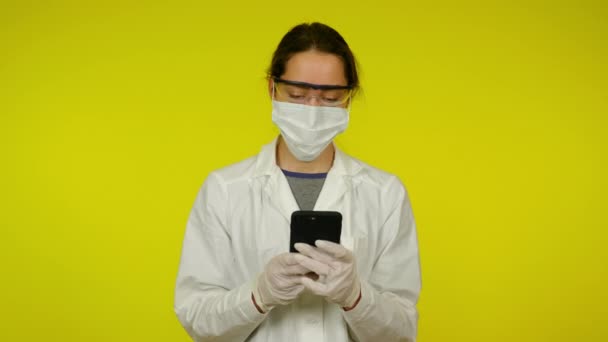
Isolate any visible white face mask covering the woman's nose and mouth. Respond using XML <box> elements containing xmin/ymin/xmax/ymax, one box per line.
<box><xmin>272</xmin><ymin>100</ymin><xmax>349</xmax><ymax>161</ymax></box>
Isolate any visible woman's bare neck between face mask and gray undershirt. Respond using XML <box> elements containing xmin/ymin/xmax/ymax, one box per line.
<box><xmin>276</xmin><ymin>137</ymin><xmax>334</xmax><ymax>173</ymax></box>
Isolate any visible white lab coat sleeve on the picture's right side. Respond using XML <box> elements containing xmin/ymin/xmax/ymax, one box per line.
<box><xmin>343</xmin><ymin>177</ymin><xmax>421</xmax><ymax>342</ymax></box>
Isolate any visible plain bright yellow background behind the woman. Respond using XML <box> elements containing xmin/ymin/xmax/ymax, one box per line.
<box><xmin>0</xmin><ymin>0</ymin><xmax>608</xmax><ymax>342</ymax></box>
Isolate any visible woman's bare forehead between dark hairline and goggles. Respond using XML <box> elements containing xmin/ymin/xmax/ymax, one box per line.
<box><xmin>281</xmin><ymin>50</ymin><xmax>348</xmax><ymax>85</ymax></box>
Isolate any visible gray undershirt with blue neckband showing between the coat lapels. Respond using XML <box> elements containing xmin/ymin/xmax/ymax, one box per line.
<box><xmin>283</xmin><ymin>170</ymin><xmax>327</xmax><ymax>210</ymax></box>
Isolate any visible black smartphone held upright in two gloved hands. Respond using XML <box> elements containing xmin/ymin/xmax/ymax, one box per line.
<box><xmin>289</xmin><ymin>210</ymin><xmax>342</xmax><ymax>253</ymax></box>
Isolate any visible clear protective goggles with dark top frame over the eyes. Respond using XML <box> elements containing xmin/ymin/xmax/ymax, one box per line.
<box><xmin>272</xmin><ymin>77</ymin><xmax>353</xmax><ymax>107</ymax></box>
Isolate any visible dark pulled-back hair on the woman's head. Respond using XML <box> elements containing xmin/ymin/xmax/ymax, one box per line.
<box><xmin>267</xmin><ymin>22</ymin><xmax>359</xmax><ymax>91</ymax></box>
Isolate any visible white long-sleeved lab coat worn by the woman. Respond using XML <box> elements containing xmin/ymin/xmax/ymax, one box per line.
<box><xmin>175</xmin><ymin>139</ymin><xmax>420</xmax><ymax>342</ymax></box>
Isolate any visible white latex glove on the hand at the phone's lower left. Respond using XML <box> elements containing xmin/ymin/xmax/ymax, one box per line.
<box><xmin>253</xmin><ymin>253</ymin><xmax>310</xmax><ymax>312</ymax></box>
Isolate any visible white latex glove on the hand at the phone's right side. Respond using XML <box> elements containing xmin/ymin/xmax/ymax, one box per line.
<box><xmin>295</xmin><ymin>240</ymin><xmax>361</xmax><ymax>308</ymax></box>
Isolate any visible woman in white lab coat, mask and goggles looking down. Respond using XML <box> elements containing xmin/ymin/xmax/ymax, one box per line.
<box><xmin>175</xmin><ymin>23</ymin><xmax>420</xmax><ymax>342</ymax></box>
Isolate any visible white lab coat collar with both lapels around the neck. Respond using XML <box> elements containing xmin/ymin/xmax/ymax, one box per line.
<box><xmin>254</xmin><ymin>138</ymin><xmax>362</xmax><ymax>222</ymax></box>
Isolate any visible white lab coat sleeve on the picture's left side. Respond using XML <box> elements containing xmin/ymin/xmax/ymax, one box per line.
<box><xmin>174</xmin><ymin>173</ymin><xmax>266</xmax><ymax>342</ymax></box>
